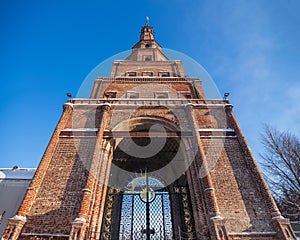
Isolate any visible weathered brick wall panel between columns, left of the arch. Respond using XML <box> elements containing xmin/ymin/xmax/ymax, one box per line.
<box><xmin>23</xmin><ymin>138</ymin><xmax>95</xmax><ymax>234</ymax></box>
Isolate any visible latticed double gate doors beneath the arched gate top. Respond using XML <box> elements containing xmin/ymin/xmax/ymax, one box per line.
<box><xmin>119</xmin><ymin>192</ymin><xmax>173</xmax><ymax>240</ymax></box>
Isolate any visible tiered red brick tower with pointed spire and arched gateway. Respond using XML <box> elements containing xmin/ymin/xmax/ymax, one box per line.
<box><xmin>3</xmin><ymin>20</ymin><xmax>296</xmax><ymax>240</ymax></box>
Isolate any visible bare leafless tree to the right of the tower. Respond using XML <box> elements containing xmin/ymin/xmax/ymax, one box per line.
<box><xmin>260</xmin><ymin>125</ymin><xmax>300</xmax><ymax>221</ymax></box>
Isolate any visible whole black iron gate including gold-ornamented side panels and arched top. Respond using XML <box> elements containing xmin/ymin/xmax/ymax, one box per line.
<box><xmin>101</xmin><ymin>176</ymin><xmax>196</xmax><ymax>240</ymax></box>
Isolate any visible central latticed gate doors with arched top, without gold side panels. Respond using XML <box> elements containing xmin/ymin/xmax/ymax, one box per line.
<box><xmin>119</xmin><ymin>174</ymin><xmax>173</xmax><ymax>240</ymax></box>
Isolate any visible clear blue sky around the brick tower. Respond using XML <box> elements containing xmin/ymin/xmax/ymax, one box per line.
<box><xmin>0</xmin><ymin>0</ymin><xmax>300</xmax><ymax>167</ymax></box>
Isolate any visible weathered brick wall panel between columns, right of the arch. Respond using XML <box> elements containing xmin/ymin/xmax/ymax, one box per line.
<box><xmin>202</xmin><ymin>138</ymin><xmax>274</xmax><ymax>232</ymax></box>
